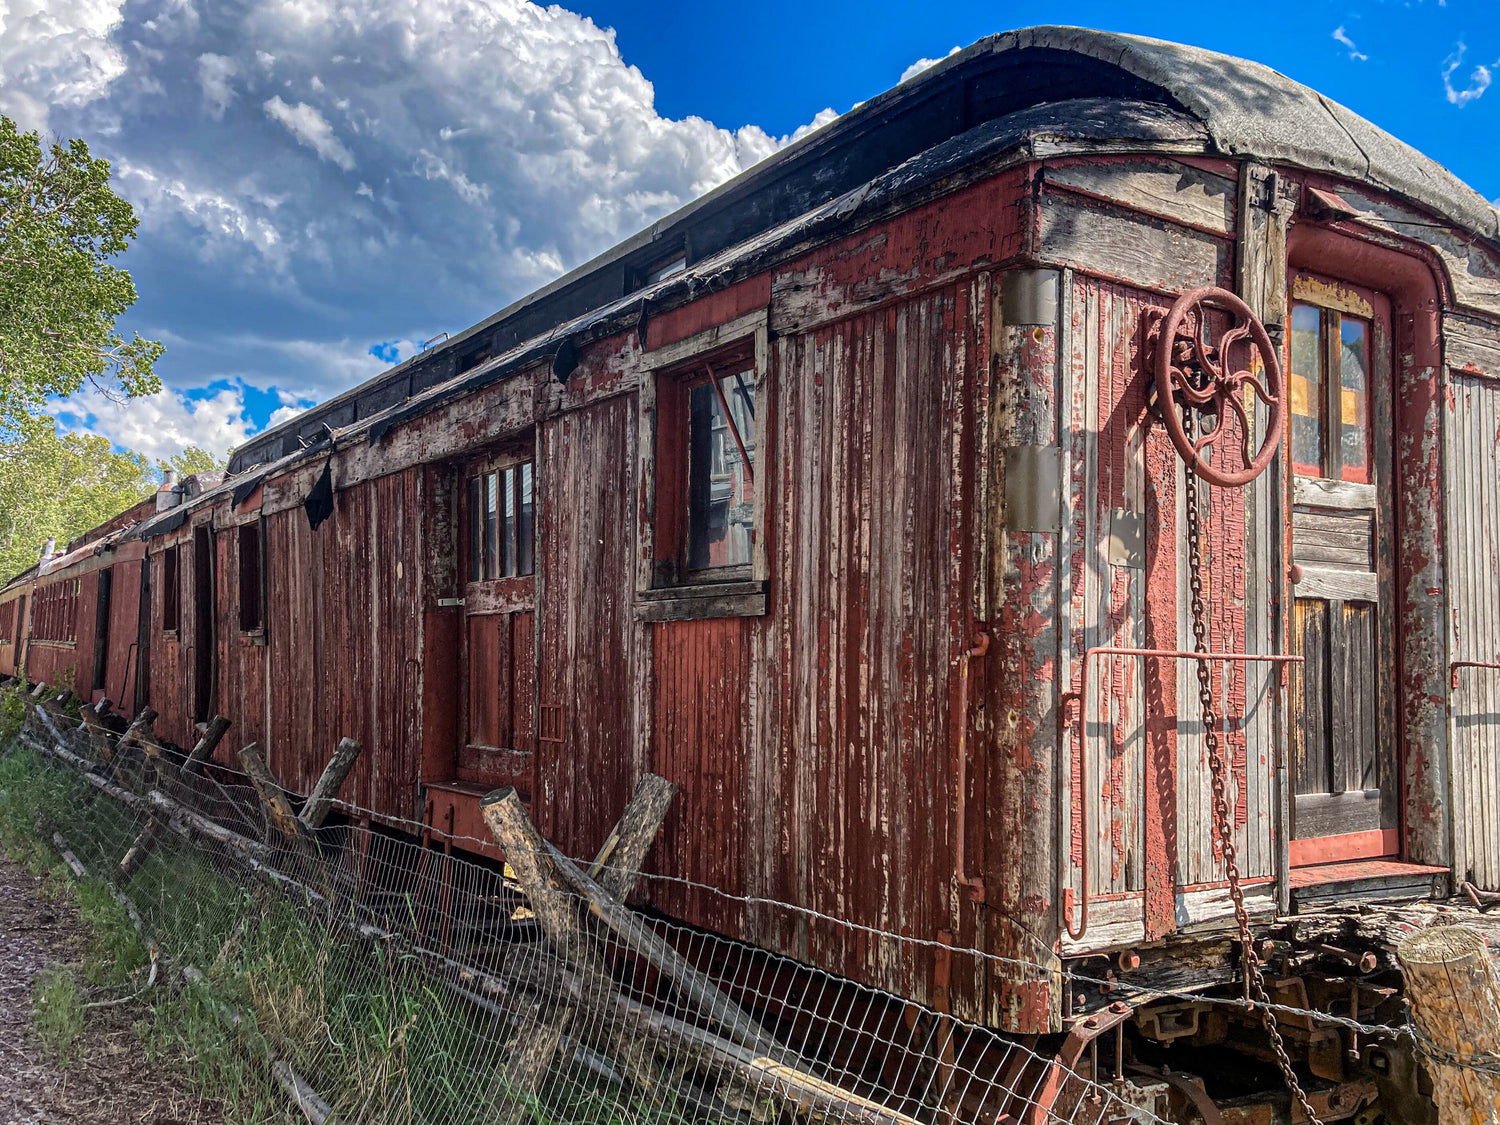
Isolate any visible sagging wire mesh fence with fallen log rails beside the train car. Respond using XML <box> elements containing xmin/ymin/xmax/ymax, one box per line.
<box><xmin>0</xmin><ymin>695</ymin><xmax>1157</xmax><ymax>1125</ymax></box>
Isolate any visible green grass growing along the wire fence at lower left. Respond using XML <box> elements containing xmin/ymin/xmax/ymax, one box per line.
<box><xmin>0</xmin><ymin>690</ymin><xmax>726</xmax><ymax>1125</ymax></box>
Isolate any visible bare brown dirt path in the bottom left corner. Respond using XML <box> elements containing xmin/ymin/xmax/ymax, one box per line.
<box><xmin>0</xmin><ymin>851</ymin><xmax>224</xmax><ymax>1125</ymax></box>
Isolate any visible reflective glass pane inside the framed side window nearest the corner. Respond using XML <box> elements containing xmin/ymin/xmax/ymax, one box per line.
<box><xmin>687</xmin><ymin>372</ymin><xmax>755</xmax><ymax>570</ymax></box>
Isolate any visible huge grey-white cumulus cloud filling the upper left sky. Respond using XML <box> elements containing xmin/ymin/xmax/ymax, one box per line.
<box><xmin>0</xmin><ymin>0</ymin><xmax>836</xmax><ymax>456</ymax></box>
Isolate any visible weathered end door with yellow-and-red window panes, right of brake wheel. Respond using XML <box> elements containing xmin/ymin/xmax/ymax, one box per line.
<box><xmin>1289</xmin><ymin>276</ymin><xmax>1400</xmax><ymax>866</ymax></box>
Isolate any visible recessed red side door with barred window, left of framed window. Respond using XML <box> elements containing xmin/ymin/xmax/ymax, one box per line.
<box><xmin>456</xmin><ymin>446</ymin><xmax>536</xmax><ymax>797</ymax></box>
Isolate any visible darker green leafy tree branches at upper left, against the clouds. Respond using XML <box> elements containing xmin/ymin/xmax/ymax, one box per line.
<box><xmin>0</xmin><ymin>117</ymin><xmax>162</xmax><ymax>437</ymax></box>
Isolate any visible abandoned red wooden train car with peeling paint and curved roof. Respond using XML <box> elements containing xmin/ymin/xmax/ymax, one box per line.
<box><xmin>0</xmin><ymin>29</ymin><xmax>1500</xmax><ymax>1119</ymax></box>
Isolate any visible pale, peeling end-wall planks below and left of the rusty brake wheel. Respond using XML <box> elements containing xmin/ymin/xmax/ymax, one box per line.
<box><xmin>1064</xmin><ymin>264</ymin><xmax>1277</xmax><ymax>948</ymax></box>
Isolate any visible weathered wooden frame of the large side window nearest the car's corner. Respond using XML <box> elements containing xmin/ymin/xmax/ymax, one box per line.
<box><xmin>636</xmin><ymin>309</ymin><xmax>774</xmax><ymax>621</ymax></box>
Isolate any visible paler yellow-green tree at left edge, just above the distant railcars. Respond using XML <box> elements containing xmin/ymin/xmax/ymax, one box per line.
<box><xmin>0</xmin><ymin>417</ymin><xmax>159</xmax><ymax>584</ymax></box>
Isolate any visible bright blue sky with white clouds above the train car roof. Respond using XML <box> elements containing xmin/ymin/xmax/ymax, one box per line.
<box><xmin>0</xmin><ymin>0</ymin><xmax>1500</xmax><ymax>456</ymax></box>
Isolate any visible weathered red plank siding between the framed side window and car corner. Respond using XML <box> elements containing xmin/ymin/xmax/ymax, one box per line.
<box><xmin>762</xmin><ymin>285</ymin><xmax>984</xmax><ymax>1004</ymax></box>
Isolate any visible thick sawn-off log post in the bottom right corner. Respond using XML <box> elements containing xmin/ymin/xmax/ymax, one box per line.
<box><xmin>1397</xmin><ymin>926</ymin><xmax>1500</xmax><ymax>1125</ymax></box>
